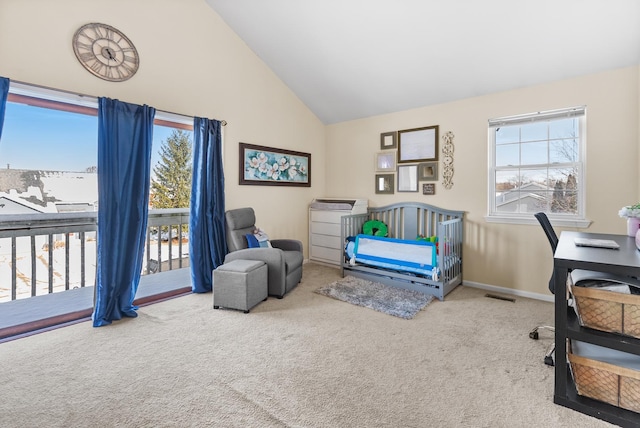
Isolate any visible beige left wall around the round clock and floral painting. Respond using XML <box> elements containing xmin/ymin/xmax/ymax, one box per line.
<box><xmin>0</xmin><ymin>0</ymin><xmax>325</xmax><ymax>254</ymax></box>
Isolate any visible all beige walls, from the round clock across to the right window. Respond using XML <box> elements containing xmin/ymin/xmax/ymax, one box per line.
<box><xmin>0</xmin><ymin>0</ymin><xmax>640</xmax><ymax>296</ymax></box>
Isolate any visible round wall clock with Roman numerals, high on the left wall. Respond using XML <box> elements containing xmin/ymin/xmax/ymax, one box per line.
<box><xmin>73</xmin><ymin>22</ymin><xmax>140</xmax><ymax>82</ymax></box>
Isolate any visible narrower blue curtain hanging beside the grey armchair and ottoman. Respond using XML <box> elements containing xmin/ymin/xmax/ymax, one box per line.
<box><xmin>189</xmin><ymin>117</ymin><xmax>227</xmax><ymax>293</ymax></box>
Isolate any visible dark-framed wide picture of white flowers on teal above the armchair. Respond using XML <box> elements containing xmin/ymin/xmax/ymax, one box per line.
<box><xmin>239</xmin><ymin>143</ymin><xmax>311</xmax><ymax>187</ymax></box>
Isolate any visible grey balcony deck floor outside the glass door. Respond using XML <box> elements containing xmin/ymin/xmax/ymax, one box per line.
<box><xmin>0</xmin><ymin>268</ymin><xmax>191</xmax><ymax>341</ymax></box>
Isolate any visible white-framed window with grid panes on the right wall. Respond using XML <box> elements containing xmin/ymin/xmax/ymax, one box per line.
<box><xmin>487</xmin><ymin>107</ymin><xmax>586</xmax><ymax>226</ymax></box>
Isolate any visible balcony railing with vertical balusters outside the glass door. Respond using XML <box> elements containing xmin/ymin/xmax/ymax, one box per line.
<box><xmin>0</xmin><ymin>208</ymin><xmax>189</xmax><ymax>302</ymax></box>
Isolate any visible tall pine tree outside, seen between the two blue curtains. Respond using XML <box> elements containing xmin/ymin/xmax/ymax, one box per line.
<box><xmin>150</xmin><ymin>130</ymin><xmax>192</xmax><ymax>208</ymax></box>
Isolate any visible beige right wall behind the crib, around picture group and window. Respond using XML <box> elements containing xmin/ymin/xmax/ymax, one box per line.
<box><xmin>327</xmin><ymin>67</ymin><xmax>639</xmax><ymax>296</ymax></box>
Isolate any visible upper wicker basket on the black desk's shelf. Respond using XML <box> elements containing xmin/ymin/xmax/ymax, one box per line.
<box><xmin>571</xmin><ymin>286</ymin><xmax>640</xmax><ymax>339</ymax></box>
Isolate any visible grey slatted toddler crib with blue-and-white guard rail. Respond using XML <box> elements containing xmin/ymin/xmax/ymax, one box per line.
<box><xmin>341</xmin><ymin>202</ymin><xmax>464</xmax><ymax>300</ymax></box>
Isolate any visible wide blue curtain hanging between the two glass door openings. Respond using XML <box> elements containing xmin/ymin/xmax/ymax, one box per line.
<box><xmin>93</xmin><ymin>98</ymin><xmax>155</xmax><ymax>327</ymax></box>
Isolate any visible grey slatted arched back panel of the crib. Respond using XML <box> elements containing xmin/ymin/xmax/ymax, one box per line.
<box><xmin>367</xmin><ymin>202</ymin><xmax>464</xmax><ymax>239</ymax></box>
